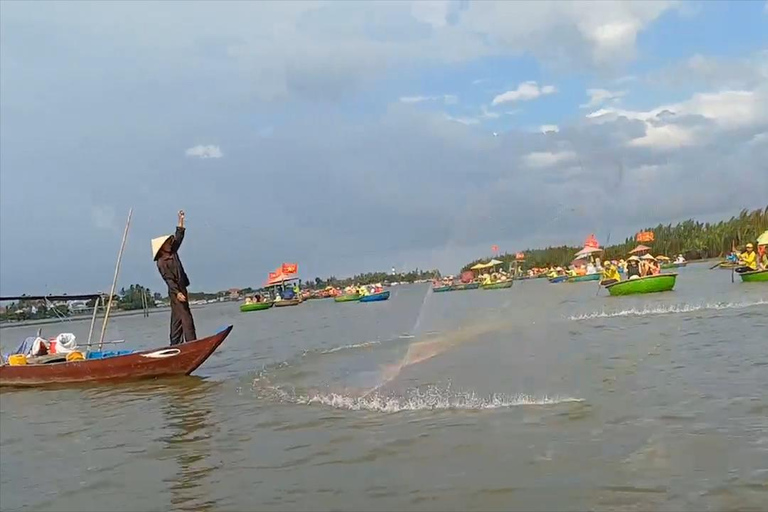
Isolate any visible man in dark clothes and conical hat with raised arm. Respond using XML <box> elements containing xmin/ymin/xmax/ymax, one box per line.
<box><xmin>152</xmin><ymin>210</ymin><xmax>197</xmax><ymax>345</ymax></box>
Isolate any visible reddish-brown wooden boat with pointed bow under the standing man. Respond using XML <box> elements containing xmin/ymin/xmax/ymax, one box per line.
<box><xmin>0</xmin><ymin>325</ymin><xmax>232</xmax><ymax>387</ymax></box>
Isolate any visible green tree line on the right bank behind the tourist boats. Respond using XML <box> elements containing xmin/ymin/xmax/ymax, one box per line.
<box><xmin>462</xmin><ymin>206</ymin><xmax>768</xmax><ymax>270</ymax></box>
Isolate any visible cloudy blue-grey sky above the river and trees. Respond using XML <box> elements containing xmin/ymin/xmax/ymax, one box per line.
<box><xmin>0</xmin><ymin>0</ymin><xmax>768</xmax><ymax>295</ymax></box>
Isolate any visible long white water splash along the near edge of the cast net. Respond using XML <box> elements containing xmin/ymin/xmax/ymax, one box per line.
<box><xmin>258</xmin><ymin>386</ymin><xmax>584</xmax><ymax>413</ymax></box>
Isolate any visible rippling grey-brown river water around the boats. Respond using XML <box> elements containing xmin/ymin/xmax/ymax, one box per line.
<box><xmin>0</xmin><ymin>265</ymin><xmax>768</xmax><ymax>511</ymax></box>
